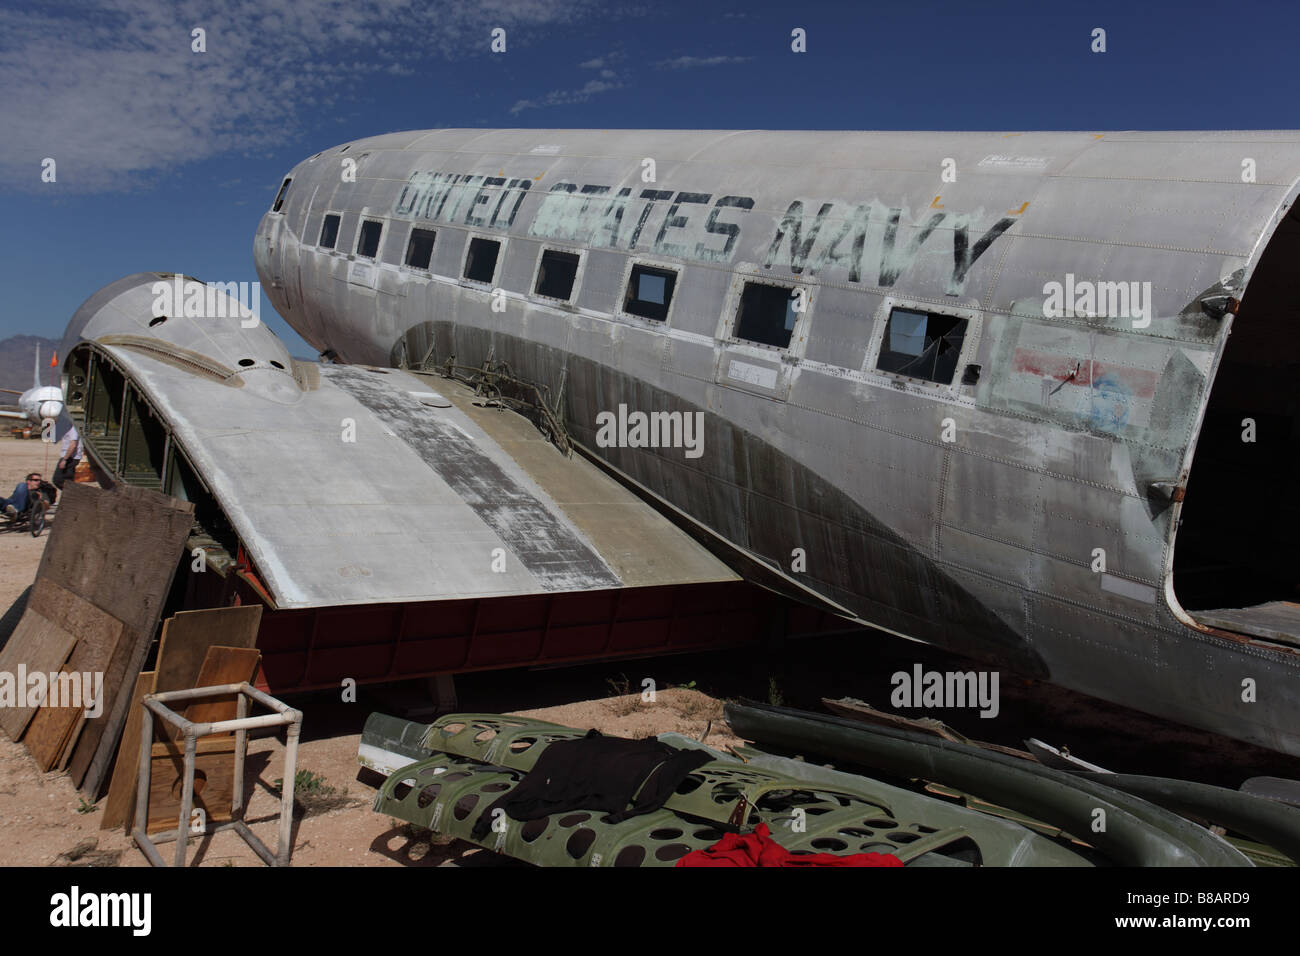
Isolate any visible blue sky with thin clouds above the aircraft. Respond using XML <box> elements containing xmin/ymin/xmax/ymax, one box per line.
<box><xmin>0</xmin><ymin>0</ymin><xmax>1300</xmax><ymax>364</ymax></box>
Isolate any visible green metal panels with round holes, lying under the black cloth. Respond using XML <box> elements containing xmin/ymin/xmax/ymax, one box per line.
<box><xmin>374</xmin><ymin>714</ymin><xmax>970</xmax><ymax>866</ymax></box>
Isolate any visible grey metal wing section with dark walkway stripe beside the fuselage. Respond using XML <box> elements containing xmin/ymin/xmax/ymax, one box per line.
<box><xmin>70</xmin><ymin>334</ymin><xmax>738</xmax><ymax>609</ymax></box>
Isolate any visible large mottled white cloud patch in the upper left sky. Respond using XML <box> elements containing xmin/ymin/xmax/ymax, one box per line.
<box><xmin>0</xmin><ymin>0</ymin><xmax>590</xmax><ymax>191</ymax></box>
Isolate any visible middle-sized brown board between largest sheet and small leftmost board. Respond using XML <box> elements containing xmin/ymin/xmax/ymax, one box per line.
<box><xmin>26</xmin><ymin>600</ymin><xmax>124</xmax><ymax>770</ymax></box>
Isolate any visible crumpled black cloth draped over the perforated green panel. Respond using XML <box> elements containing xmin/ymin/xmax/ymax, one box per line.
<box><xmin>472</xmin><ymin>730</ymin><xmax>712</xmax><ymax>840</ymax></box>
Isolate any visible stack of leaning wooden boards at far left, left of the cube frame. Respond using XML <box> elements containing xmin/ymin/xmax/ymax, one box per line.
<box><xmin>0</xmin><ymin>484</ymin><xmax>194</xmax><ymax>800</ymax></box>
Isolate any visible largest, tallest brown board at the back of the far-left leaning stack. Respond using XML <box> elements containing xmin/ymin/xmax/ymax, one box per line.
<box><xmin>53</xmin><ymin>484</ymin><xmax>194</xmax><ymax>800</ymax></box>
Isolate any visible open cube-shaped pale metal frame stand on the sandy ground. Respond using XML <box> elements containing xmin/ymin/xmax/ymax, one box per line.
<box><xmin>131</xmin><ymin>682</ymin><xmax>303</xmax><ymax>866</ymax></box>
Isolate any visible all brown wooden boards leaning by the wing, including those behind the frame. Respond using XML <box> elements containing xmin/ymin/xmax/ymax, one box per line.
<box><xmin>0</xmin><ymin>485</ymin><xmax>261</xmax><ymax>832</ymax></box>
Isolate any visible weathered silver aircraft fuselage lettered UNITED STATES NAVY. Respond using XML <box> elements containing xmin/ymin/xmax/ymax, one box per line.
<box><xmin>255</xmin><ymin>130</ymin><xmax>1300</xmax><ymax>753</ymax></box>
